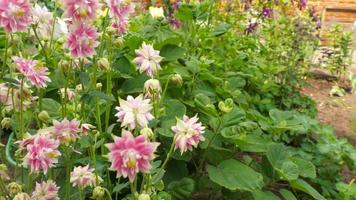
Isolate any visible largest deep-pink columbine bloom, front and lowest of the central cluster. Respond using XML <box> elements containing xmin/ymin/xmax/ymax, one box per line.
<box><xmin>106</xmin><ymin>131</ymin><xmax>159</xmax><ymax>182</ymax></box>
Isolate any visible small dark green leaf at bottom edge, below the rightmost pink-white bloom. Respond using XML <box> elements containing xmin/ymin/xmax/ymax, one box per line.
<box><xmin>167</xmin><ymin>178</ymin><xmax>195</xmax><ymax>200</ymax></box>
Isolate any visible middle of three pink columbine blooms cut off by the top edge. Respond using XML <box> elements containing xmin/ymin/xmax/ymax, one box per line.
<box><xmin>64</xmin><ymin>0</ymin><xmax>98</xmax><ymax>21</ymax></box>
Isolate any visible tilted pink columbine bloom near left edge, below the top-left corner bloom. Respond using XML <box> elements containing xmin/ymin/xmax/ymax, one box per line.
<box><xmin>13</xmin><ymin>57</ymin><xmax>51</xmax><ymax>88</ymax></box>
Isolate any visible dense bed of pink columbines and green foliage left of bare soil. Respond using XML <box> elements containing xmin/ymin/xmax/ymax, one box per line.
<box><xmin>0</xmin><ymin>0</ymin><xmax>356</xmax><ymax>200</ymax></box>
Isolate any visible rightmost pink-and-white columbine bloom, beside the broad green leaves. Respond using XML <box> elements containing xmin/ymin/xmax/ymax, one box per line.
<box><xmin>172</xmin><ymin>115</ymin><xmax>205</xmax><ymax>154</ymax></box>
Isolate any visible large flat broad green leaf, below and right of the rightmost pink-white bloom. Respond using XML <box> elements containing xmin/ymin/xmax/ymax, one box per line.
<box><xmin>208</xmin><ymin>159</ymin><xmax>263</xmax><ymax>191</ymax></box>
